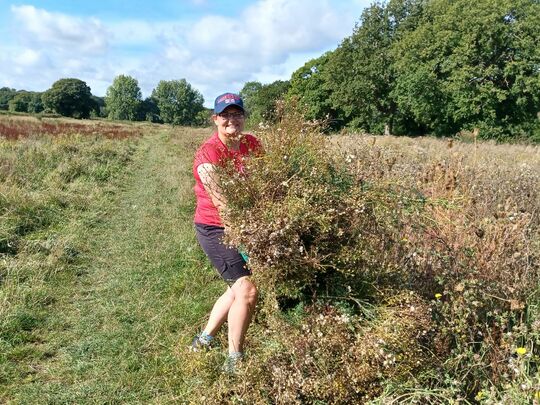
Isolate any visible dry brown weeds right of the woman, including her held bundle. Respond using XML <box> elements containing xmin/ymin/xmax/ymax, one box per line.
<box><xmin>196</xmin><ymin>105</ymin><xmax>540</xmax><ymax>404</ymax></box>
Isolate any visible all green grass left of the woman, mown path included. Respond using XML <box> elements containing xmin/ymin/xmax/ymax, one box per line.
<box><xmin>0</xmin><ymin>117</ymin><xmax>226</xmax><ymax>404</ymax></box>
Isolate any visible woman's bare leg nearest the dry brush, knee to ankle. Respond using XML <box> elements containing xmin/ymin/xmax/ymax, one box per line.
<box><xmin>227</xmin><ymin>276</ymin><xmax>257</xmax><ymax>353</ymax></box>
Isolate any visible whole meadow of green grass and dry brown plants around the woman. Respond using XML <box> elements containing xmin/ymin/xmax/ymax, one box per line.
<box><xmin>0</xmin><ymin>115</ymin><xmax>540</xmax><ymax>404</ymax></box>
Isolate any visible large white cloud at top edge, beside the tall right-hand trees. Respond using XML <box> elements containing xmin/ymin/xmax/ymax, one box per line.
<box><xmin>186</xmin><ymin>0</ymin><xmax>355</xmax><ymax>64</ymax></box>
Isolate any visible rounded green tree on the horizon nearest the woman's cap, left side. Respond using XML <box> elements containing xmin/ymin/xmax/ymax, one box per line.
<box><xmin>152</xmin><ymin>79</ymin><xmax>204</xmax><ymax>125</ymax></box>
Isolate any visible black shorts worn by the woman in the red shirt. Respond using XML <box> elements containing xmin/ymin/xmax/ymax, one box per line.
<box><xmin>195</xmin><ymin>223</ymin><xmax>251</xmax><ymax>285</ymax></box>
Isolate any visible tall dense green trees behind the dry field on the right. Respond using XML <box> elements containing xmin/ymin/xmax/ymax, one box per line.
<box><xmin>241</xmin><ymin>0</ymin><xmax>540</xmax><ymax>141</ymax></box>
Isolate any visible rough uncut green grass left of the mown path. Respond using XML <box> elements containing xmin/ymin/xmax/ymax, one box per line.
<box><xmin>0</xmin><ymin>125</ymin><xmax>136</xmax><ymax>392</ymax></box>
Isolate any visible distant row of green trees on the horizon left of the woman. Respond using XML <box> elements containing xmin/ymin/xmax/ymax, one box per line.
<box><xmin>0</xmin><ymin>75</ymin><xmax>208</xmax><ymax>126</ymax></box>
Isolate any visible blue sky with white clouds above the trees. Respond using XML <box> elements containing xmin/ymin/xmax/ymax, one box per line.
<box><xmin>0</xmin><ymin>0</ymin><xmax>371</xmax><ymax>106</ymax></box>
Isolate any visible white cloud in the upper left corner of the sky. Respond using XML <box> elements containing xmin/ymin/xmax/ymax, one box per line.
<box><xmin>11</xmin><ymin>5</ymin><xmax>108</xmax><ymax>53</ymax></box>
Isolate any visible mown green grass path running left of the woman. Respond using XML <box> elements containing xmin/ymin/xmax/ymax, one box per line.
<box><xmin>4</xmin><ymin>129</ymin><xmax>222</xmax><ymax>404</ymax></box>
